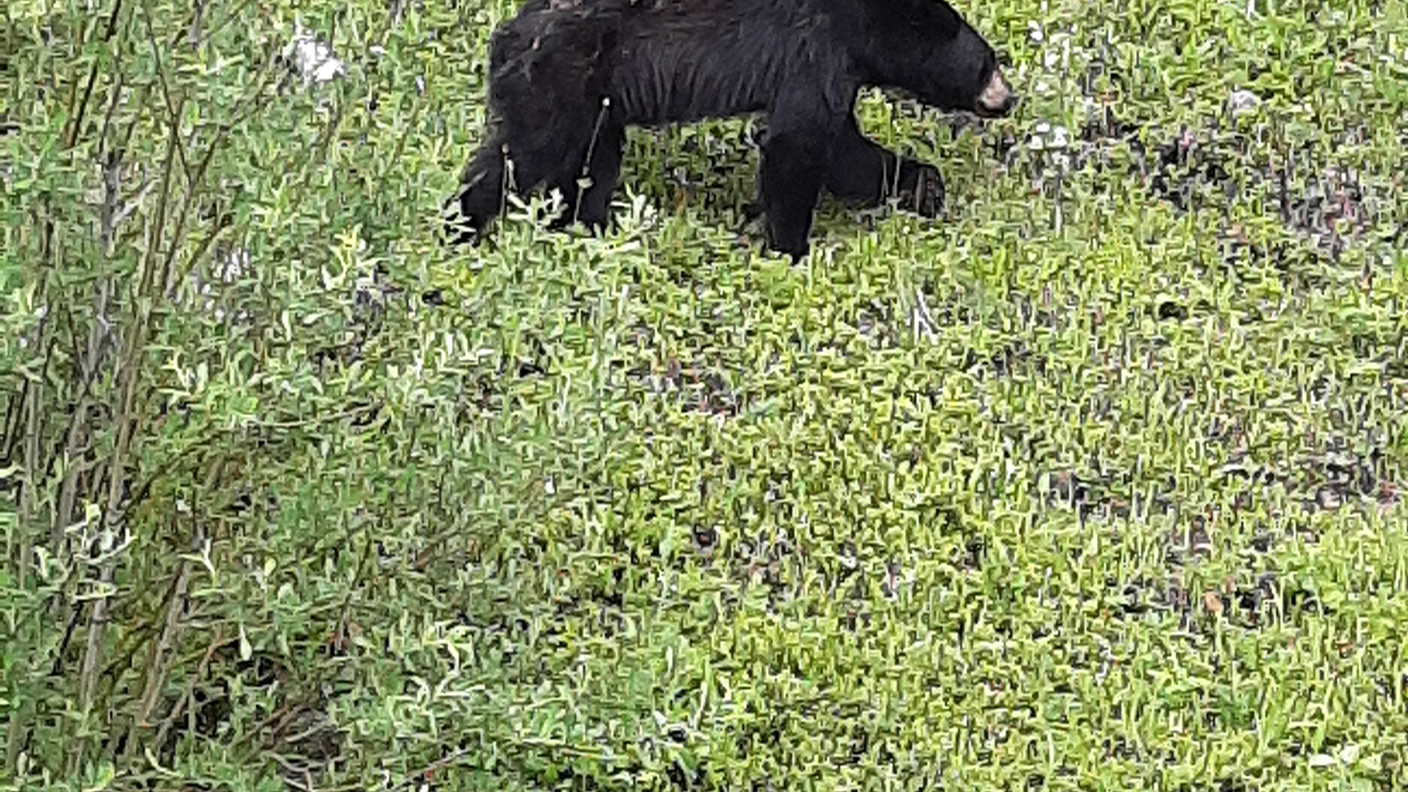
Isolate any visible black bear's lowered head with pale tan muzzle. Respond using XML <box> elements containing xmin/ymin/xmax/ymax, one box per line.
<box><xmin>863</xmin><ymin>0</ymin><xmax>1017</xmax><ymax>118</ymax></box>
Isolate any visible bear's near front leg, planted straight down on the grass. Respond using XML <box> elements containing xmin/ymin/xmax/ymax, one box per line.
<box><xmin>759</xmin><ymin>99</ymin><xmax>843</xmax><ymax>264</ymax></box>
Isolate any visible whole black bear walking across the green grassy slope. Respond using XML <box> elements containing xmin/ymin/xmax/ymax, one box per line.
<box><xmin>448</xmin><ymin>0</ymin><xmax>1015</xmax><ymax>261</ymax></box>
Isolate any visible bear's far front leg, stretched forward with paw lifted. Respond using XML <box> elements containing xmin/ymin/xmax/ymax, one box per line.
<box><xmin>826</xmin><ymin>116</ymin><xmax>943</xmax><ymax>217</ymax></box>
